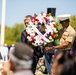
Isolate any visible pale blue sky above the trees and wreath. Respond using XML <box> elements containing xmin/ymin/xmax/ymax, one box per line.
<box><xmin>0</xmin><ymin>0</ymin><xmax>76</xmax><ymax>27</ymax></box>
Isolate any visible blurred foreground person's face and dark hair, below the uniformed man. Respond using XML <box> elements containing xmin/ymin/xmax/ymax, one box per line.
<box><xmin>52</xmin><ymin>50</ymin><xmax>74</xmax><ymax>75</ymax></box>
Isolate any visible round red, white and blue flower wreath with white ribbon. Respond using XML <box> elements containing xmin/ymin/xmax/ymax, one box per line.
<box><xmin>26</xmin><ymin>13</ymin><xmax>57</xmax><ymax>46</ymax></box>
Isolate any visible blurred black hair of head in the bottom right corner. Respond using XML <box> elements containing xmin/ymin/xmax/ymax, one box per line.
<box><xmin>60</xmin><ymin>59</ymin><xmax>76</xmax><ymax>75</ymax></box>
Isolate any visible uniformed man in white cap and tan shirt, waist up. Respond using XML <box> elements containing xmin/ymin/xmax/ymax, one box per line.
<box><xmin>45</xmin><ymin>14</ymin><xmax>76</xmax><ymax>54</ymax></box>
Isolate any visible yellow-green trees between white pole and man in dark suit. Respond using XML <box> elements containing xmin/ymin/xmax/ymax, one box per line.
<box><xmin>5</xmin><ymin>24</ymin><xmax>24</xmax><ymax>45</ymax></box>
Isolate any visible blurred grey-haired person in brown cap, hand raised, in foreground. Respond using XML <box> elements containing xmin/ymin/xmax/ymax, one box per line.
<box><xmin>2</xmin><ymin>43</ymin><xmax>33</xmax><ymax>75</ymax></box>
